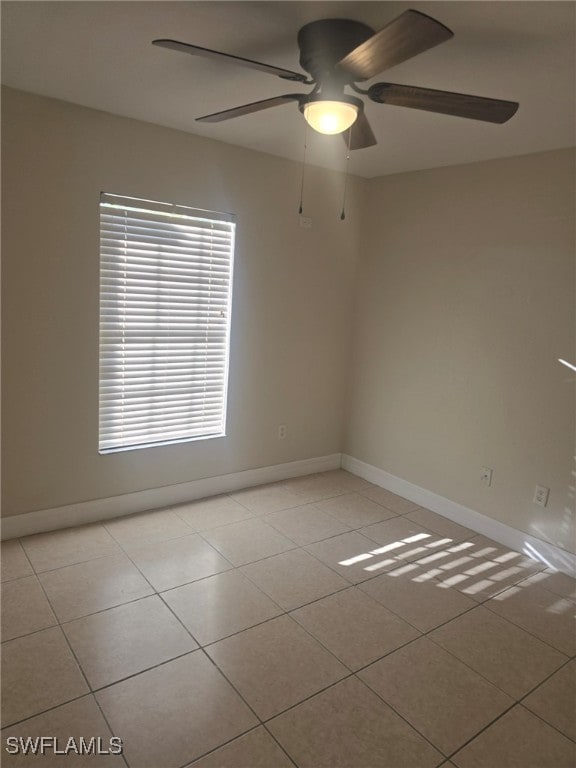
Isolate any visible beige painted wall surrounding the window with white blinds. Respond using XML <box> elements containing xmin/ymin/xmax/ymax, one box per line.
<box><xmin>2</xmin><ymin>89</ymin><xmax>364</xmax><ymax>515</ymax></box>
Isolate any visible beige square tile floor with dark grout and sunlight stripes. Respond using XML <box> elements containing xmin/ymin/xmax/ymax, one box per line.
<box><xmin>2</xmin><ymin>470</ymin><xmax>576</xmax><ymax>768</ymax></box>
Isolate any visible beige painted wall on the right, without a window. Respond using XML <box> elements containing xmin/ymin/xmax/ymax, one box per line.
<box><xmin>346</xmin><ymin>150</ymin><xmax>576</xmax><ymax>550</ymax></box>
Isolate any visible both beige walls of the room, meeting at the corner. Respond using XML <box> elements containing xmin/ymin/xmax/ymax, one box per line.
<box><xmin>2</xmin><ymin>89</ymin><xmax>576</xmax><ymax>550</ymax></box>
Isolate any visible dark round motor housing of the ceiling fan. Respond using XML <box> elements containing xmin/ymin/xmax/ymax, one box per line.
<box><xmin>298</xmin><ymin>19</ymin><xmax>374</xmax><ymax>85</ymax></box>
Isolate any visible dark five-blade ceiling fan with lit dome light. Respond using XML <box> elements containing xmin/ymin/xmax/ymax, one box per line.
<box><xmin>152</xmin><ymin>10</ymin><xmax>518</xmax><ymax>149</ymax></box>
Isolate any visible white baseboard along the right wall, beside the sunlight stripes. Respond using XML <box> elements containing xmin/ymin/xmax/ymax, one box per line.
<box><xmin>342</xmin><ymin>454</ymin><xmax>576</xmax><ymax>577</ymax></box>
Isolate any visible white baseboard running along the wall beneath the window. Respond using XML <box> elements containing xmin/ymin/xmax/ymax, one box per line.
<box><xmin>1</xmin><ymin>453</ymin><xmax>341</xmax><ymax>540</ymax></box>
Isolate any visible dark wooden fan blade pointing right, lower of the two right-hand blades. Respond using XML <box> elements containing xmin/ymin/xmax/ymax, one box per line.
<box><xmin>368</xmin><ymin>83</ymin><xmax>518</xmax><ymax>123</ymax></box>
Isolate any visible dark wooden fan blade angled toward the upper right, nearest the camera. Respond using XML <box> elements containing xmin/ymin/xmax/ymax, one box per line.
<box><xmin>338</xmin><ymin>11</ymin><xmax>454</xmax><ymax>80</ymax></box>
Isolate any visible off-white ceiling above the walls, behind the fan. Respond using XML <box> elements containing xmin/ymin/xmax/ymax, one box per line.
<box><xmin>2</xmin><ymin>0</ymin><xmax>576</xmax><ymax>177</ymax></box>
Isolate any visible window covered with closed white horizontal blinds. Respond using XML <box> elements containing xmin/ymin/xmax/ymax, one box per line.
<box><xmin>99</xmin><ymin>194</ymin><xmax>235</xmax><ymax>453</ymax></box>
